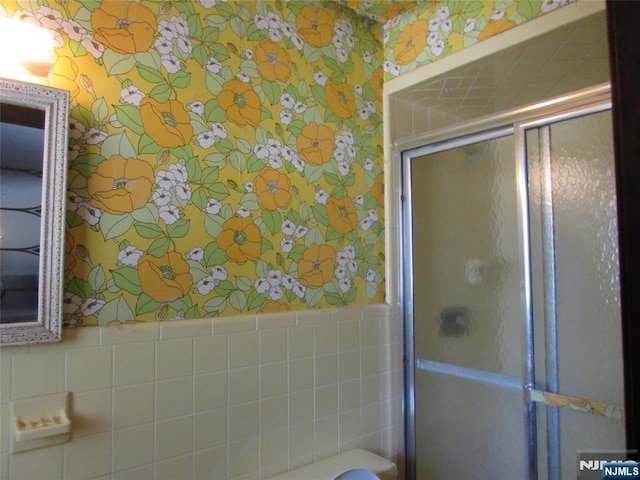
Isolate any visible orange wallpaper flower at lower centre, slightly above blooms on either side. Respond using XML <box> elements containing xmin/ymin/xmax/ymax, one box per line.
<box><xmin>218</xmin><ymin>217</ymin><xmax>262</xmax><ymax>263</ymax></box>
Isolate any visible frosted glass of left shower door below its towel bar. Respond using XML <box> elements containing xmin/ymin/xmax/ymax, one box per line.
<box><xmin>416</xmin><ymin>370</ymin><xmax>525</xmax><ymax>480</ymax></box>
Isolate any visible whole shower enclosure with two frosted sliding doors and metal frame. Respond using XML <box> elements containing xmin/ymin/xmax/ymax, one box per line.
<box><xmin>401</xmin><ymin>84</ymin><xmax>625</xmax><ymax>480</ymax></box>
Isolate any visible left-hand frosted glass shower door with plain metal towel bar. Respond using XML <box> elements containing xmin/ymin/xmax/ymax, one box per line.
<box><xmin>402</xmin><ymin>131</ymin><xmax>526</xmax><ymax>480</ymax></box>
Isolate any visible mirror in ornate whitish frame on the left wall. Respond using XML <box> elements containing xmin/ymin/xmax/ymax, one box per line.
<box><xmin>0</xmin><ymin>79</ymin><xmax>69</xmax><ymax>346</ymax></box>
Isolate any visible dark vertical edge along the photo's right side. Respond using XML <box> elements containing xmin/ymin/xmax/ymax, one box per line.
<box><xmin>594</xmin><ymin>0</ymin><xmax>640</xmax><ymax>460</ymax></box>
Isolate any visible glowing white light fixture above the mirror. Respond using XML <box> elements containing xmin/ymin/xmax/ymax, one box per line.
<box><xmin>0</xmin><ymin>16</ymin><xmax>53</xmax><ymax>81</ymax></box>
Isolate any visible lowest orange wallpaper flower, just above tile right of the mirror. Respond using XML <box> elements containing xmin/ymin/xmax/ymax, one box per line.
<box><xmin>138</xmin><ymin>252</ymin><xmax>193</xmax><ymax>303</ymax></box>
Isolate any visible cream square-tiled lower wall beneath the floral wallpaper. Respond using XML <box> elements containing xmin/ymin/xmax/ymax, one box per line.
<box><xmin>0</xmin><ymin>305</ymin><xmax>402</xmax><ymax>480</ymax></box>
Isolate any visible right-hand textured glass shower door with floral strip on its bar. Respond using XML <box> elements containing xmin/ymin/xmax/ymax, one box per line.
<box><xmin>525</xmin><ymin>110</ymin><xmax>625</xmax><ymax>480</ymax></box>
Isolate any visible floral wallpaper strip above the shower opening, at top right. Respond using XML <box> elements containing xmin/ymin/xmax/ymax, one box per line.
<box><xmin>382</xmin><ymin>0</ymin><xmax>576</xmax><ymax>79</ymax></box>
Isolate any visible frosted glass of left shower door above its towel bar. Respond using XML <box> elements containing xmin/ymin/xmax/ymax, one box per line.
<box><xmin>411</xmin><ymin>136</ymin><xmax>522</xmax><ymax>377</ymax></box>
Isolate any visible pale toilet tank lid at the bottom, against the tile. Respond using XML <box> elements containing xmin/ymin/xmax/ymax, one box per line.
<box><xmin>271</xmin><ymin>448</ymin><xmax>398</xmax><ymax>480</ymax></box>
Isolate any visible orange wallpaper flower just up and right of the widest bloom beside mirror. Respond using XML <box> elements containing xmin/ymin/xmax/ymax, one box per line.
<box><xmin>140</xmin><ymin>97</ymin><xmax>193</xmax><ymax>148</ymax></box>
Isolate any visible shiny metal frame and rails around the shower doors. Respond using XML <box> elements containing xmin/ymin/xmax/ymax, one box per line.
<box><xmin>394</xmin><ymin>83</ymin><xmax>611</xmax><ymax>480</ymax></box>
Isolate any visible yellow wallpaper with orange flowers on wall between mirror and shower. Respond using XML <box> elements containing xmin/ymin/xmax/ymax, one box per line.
<box><xmin>0</xmin><ymin>0</ymin><xmax>385</xmax><ymax>326</ymax></box>
